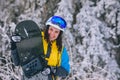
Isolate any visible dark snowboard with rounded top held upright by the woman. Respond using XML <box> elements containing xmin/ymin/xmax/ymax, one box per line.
<box><xmin>15</xmin><ymin>20</ymin><xmax>45</xmax><ymax>78</ymax></box>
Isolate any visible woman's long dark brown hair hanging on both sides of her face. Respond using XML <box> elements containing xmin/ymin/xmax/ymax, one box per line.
<box><xmin>44</xmin><ymin>26</ymin><xmax>63</xmax><ymax>51</ymax></box>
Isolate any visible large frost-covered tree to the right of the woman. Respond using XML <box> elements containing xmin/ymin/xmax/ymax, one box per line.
<box><xmin>71</xmin><ymin>0</ymin><xmax>120</xmax><ymax>80</ymax></box>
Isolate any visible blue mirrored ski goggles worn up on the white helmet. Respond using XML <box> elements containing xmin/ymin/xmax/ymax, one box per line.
<box><xmin>51</xmin><ymin>16</ymin><xmax>66</xmax><ymax>29</ymax></box>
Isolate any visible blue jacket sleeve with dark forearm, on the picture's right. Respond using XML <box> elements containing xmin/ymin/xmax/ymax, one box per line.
<box><xmin>56</xmin><ymin>48</ymin><xmax>70</xmax><ymax>77</ymax></box>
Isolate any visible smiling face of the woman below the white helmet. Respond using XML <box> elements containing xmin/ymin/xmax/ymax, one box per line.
<box><xmin>48</xmin><ymin>26</ymin><xmax>60</xmax><ymax>41</ymax></box>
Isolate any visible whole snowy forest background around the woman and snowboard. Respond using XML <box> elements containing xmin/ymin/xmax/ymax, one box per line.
<box><xmin>0</xmin><ymin>0</ymin><xmax>120</xmax><ymax>80</ymax></box>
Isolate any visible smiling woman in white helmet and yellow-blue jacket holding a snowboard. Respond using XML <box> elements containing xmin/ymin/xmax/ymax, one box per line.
<box><xmin>11</xmin><ymin>16</ymin><xmax>70</xmax><ymax>80</ymax></box>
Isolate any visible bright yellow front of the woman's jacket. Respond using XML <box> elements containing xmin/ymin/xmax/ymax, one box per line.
<box><xmin>42</xmin><ymin>32</ymin><xmax>61</xmax><ymax>67</ymax></box>
